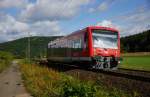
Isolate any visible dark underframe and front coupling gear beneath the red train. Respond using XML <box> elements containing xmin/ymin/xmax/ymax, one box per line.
<box><xmin>48</xmin><ymin>56</ymin><xmax>120</xmax><ymax>70</ymax></box>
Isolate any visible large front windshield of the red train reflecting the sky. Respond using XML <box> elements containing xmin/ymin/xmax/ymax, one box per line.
<box><xmin>92</xmin><ymin>30</ymin><xmax>118</xmax><ymax>49</ymax></box>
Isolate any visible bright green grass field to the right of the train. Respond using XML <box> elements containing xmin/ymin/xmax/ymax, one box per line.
<box><xmin>120</xmin><ymin>55</ymin><xmax>150</xmax><ymax>71</ymax></box>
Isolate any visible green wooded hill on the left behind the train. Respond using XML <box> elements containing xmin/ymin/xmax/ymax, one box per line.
<box><xmin>0</xmin><ymin>36</ymin><xmax>60</xmax><ymax>58</ymax></box>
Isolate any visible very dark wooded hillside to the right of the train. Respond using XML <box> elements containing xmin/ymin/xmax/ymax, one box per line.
<box><xmin>121</xmin><ymin>30</ymin><xmax>150</xmax><ymax>52</ymax></box>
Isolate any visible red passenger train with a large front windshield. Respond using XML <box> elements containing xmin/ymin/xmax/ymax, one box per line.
<box><xmin>47</xmin><ymin>26</ymin><xmax>121</xmax><ymax>70</ymax></box>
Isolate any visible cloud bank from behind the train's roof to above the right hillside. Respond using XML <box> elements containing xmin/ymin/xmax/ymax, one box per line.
<box><xmin>97</xmin><ymin>5</ymin><xmax>150</xmax><ymax>37</ymax></box>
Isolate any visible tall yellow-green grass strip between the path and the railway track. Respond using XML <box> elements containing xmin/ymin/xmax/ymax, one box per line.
<box><xmin>20</xmin><ymin>61</ymin><xmax>130</xmax><ymax>97</ymax></box>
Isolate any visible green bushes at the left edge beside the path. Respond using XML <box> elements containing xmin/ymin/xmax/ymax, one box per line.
<box><xmin>0</xmin><ymin>51</ymin><xmax>13</xmax><ymax>72</ymax></box>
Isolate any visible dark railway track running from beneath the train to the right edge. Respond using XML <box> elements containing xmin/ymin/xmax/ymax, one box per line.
<box><xmin>46</xmin><ymin>64</ymin><xmax>150</xmax><ymax>83</ymax></box>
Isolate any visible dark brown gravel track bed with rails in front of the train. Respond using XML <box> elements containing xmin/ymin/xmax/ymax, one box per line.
<box><xmin>40</xmin><ymin>64</ymin><xmax>150</xmax><ymax>97</ymax></box>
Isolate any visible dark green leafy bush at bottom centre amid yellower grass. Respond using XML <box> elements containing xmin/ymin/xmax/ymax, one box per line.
<box><xmin>61</xmin><ymin>80</ymin><xmax>97</xmax><ymax>97</ymax></box>
